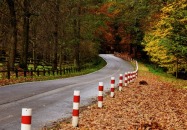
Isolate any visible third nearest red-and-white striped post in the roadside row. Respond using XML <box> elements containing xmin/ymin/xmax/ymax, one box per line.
<box><xmin>98</xmin><ymin>82</ymin><xmax>103</xmax><ymax>108</ymax></box>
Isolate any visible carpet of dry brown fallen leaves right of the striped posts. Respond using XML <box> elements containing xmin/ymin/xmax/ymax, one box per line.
<box><xmin>49</xmin><ymin>73</ymin><xmax>187</xmax><ymax>130</ymax></box>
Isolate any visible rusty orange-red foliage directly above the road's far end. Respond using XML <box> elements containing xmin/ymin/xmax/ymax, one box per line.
<box><xmin>96</xmin><ymin>2</ymin><xmax>132</xmax><ymax>53</ymax></box>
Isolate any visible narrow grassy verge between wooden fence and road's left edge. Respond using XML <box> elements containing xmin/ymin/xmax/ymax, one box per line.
<box><xmin>0</xmin><ymin>57</ymin><xmax>106</xmax><ymax>87</ymax></box>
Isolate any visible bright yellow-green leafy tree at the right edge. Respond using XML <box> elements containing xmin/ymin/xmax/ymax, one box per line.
<box><xmin>144</xmin><ymin>0</ymin><xmax>187</xmax><ymax>77</ymax></box>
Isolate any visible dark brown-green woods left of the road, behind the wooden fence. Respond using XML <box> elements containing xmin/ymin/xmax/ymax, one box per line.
<box><xmin>0</xmin><ymin>0</ymin><xmax>99</xmax><ymax>70</ymax></box>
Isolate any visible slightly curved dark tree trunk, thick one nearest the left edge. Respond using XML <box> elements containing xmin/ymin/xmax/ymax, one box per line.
<box><xmin>6</xmin><ymin>0</ymin><xmax>17</xmax><ymax>70</ymax></box>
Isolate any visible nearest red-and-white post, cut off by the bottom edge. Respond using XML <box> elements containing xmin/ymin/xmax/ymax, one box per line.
<box><xmin>21</xmin><ymin>108</ymin><xmax>32</xmax><ymax>130</ymax></box>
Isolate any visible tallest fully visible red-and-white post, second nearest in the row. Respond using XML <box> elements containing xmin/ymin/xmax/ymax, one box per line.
<box><xmin>72</xmin><ymin>90</ymin><xmax>80</xmax><ymax>127</ymax></box>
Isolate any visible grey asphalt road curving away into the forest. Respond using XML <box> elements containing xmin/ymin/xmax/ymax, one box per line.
<box><xmin>0</xmin><ymin>54</ymin><xmax>133</xmax><ymax>130</ymax></box>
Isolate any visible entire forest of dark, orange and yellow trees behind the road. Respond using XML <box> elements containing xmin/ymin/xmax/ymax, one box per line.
<box><xmin>0</xmin><ymin>0</ymin><xmax>187</xmax><ymax>77</ymax></box>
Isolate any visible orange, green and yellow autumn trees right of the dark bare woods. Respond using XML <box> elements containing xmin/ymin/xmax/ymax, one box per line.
<box><xmin>96</xmin><ymin>0</ymin><xmax>187</xmax><ymax>77</ymax></box>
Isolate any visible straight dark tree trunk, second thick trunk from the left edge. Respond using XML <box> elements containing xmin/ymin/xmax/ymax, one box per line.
<box><xmin>20</xmin><ymin>0</ymin><xmax>30</xmax><ymax>69</ymax></box>
